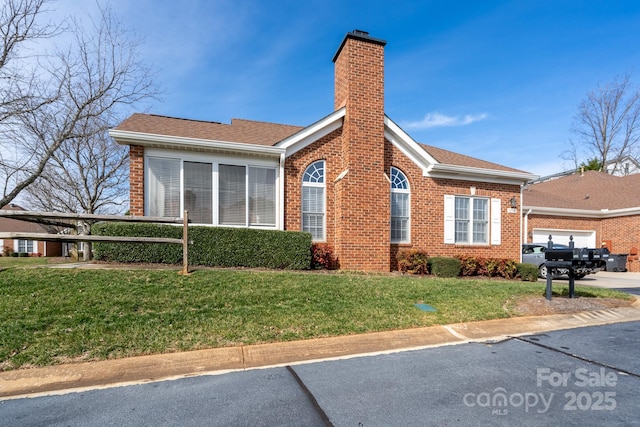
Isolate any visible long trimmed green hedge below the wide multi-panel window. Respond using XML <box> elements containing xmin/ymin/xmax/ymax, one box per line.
<box><xmin>91</xmin><ymin>223</ymin><xmax>311</xmax><ymax>270</ymax></box>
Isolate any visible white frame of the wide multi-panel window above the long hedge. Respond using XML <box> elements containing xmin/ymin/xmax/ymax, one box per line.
<box><xmin>144</xmin><ymin>148</ymin><xmax>283</xmax><ymax>230</ymax></box>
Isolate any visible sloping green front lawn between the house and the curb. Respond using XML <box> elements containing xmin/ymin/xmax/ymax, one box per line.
<box><xmin>0</xmin><ymin>268</ymin><xmax>624</xmax><ymax>370</ymax></box>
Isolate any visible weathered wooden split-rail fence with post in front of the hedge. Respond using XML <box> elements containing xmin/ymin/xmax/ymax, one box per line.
<box><xmin>0</xmin><ymin>210</ymin><xmax>189</xmax><ymax>274</ymax></box>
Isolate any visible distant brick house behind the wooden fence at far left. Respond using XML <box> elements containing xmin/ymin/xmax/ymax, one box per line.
<box><xmin>0</xmin><ymin>203</ymin><xmax>62</xmax><ymax>256</ymax></box>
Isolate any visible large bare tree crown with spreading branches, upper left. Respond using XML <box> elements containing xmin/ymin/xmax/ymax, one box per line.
<box><xmin>0</xmin><ymin>0</ymin><xmax>157</xmax><ymax>209</ymax></box>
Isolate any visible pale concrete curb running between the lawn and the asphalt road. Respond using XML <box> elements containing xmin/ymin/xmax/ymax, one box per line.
<box><xmin>0</xmin><ymin>299</ymin><xmax>640</xmax><ymax>400</ymax></box>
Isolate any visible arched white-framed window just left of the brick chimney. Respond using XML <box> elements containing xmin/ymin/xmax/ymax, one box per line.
<box><xmin>302</xmin><ymin>160</ymin><xmax>325</xmax><ymax>241</ymax></box>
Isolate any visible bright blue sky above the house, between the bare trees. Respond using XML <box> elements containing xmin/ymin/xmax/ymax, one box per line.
<box><xmin>57</xmin><ymin>0</ymin><xmax>640</xmax><ymax>175</ymax></box>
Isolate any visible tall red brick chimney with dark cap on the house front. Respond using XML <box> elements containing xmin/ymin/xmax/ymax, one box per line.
<box><xmin>333</xmin><ymin>30</ymin><xmax>391</xmax><ymax>271</ymax></box>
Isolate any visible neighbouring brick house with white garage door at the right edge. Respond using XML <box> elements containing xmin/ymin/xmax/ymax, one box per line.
<box><xmin>522</xmin><ymin>171</ymin><xmax>640</xmax><ymax>272</ymax></box>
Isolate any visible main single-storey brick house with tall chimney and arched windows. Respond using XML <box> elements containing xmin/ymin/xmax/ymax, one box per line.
<box><xmin>111</xmin><ymin>31</ymin><xmax>534</xmax><ymax>271</ymax></box>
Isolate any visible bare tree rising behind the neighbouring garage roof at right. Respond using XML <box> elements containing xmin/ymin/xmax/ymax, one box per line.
<box><xmin>565</xmin><ymin>75</ymin><xmax>640</xmax><ymax>172</ymax></box>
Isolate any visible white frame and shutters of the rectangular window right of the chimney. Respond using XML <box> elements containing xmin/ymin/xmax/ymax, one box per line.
<box><xmin>444</xmin><ymin>195</ymin><xmax>502</xmax><ymax>246</ymax></box>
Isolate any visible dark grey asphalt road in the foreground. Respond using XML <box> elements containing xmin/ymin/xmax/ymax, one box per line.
<box><xmin>0</xmin><ymin>322</ymin><xmax>640</xmax><ymax>426</ymax></box>
